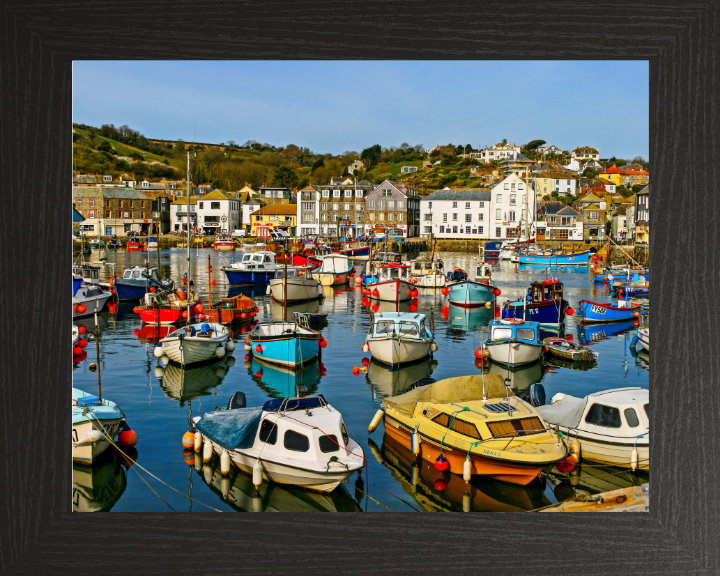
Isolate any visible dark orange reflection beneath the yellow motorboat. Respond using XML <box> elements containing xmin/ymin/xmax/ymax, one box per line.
<box><xmin>368</xmin><ymin>434</ymin><xmax>551</xmax><ymax>512</ymax></box>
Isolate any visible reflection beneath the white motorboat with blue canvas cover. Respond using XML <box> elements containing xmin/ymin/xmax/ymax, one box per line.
<box><xmin>195</xmin><ymin>454</ymin><xmax>362</xmax><ymax>512</ymax></box>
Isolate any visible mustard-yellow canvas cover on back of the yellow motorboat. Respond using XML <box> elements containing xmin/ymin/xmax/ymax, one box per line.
<box><xmin>382</xmin><ymin>374</ymin><xmax>513</xmax><ymax>416</ymax></box>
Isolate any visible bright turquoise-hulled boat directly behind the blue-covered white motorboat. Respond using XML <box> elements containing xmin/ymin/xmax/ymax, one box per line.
<box><xmin>248</xmin><ymin>321</ymin><xmax>324</xmax><ymax>368</ymax></box>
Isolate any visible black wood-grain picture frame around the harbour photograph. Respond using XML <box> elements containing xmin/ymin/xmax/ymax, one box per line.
<box><xmin>0</xmin><ymin>0</ymin><xmax>720</xmax><ymax>576</ymax></box>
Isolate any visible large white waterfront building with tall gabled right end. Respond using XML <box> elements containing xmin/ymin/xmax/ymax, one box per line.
<box><xmin>420</xmin><ymin>174</ymin><xmax>535</xmax><ymax>240</ymax></box>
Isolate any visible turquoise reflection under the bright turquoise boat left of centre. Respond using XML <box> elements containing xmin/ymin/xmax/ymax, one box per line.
<box><xmin>250</xmin><ymin>356</ymin><xmax>323</xmax><ymax>398</ymax></box>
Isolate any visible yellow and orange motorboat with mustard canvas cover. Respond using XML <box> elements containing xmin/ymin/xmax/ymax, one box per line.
<box><xmin>368</xmin><ymin>374</ymin><xmax>567</xmax><ymax>485</ymax></box>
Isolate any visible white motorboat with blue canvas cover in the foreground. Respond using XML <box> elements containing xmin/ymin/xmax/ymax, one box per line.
<box><xmin>193</xmin><ymin>395</ymin><xmax>365</xmax><ymax>492</ymax></box>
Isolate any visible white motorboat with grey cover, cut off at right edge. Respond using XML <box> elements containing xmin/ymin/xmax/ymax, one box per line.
<box><xmin>537</xmin><ymin>388</ymin><xmax>650</xmax><ymax>470</ymax></box>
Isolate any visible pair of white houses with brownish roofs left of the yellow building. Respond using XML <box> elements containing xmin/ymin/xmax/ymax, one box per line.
<box><xmin>170</xmin><ymin>190</ymin><xmax>242</xmax><ymax>235</ymax></box>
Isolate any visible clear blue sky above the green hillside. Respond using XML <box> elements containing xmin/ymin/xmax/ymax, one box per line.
<box><xmin>73</xmin><ymin>60</ymin><xmax>649</xmax><ymax>160</ymax></box>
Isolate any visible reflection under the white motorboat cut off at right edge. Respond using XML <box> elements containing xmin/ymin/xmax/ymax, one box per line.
<box><xmin>541</xmin><ymin>455</ymin><xmax>650</xmax><ymax>502</ymax></box>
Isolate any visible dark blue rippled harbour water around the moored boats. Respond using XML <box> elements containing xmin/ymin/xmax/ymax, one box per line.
<box><xmin>73</xmin><ymin>249</ymin><xmax>649</xmax><ymax>512</ymax></box>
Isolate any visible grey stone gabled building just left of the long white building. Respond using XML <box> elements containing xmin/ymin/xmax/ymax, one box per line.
<box><xmin>365</xmin><ymin>180</ymin><xmax>420</xmax><ymax>238</ymax></box>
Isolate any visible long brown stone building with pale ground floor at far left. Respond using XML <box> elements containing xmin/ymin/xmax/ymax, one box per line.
<box><xmin>72</xmin><ymin>186</ymin><xmax>153</xmax><ymax>236</ymax></box>
